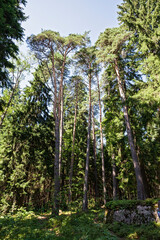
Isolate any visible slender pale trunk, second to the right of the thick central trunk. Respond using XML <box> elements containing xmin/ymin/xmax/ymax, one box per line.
<box><xmin>97</xmin><ymin>76</ymin><xmax>106</xmax><ymax>205</ymax></box>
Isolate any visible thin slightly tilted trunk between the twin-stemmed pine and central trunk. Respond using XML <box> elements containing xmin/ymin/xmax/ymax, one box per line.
<box><xmin>68</xmin><ymin>82</ymin><xmax>78</xmax><ymax>202</ymax></box>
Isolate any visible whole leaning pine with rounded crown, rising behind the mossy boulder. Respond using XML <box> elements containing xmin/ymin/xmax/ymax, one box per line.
<box><xmin>97</xmin><ymin>28</ymin><xmax>145</xmax><ymax>199</ymax></box>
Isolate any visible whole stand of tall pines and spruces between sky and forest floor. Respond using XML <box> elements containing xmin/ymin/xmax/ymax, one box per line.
<box><xmin>0</xmin><ymin>0</ymin><xmax>160</xmax><ymax>215</ymax></box>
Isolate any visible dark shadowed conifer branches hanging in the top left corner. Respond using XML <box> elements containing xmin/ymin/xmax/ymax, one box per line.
<box><xmin>0</xmin><ymin>0</ymin><xmax>26</xmax><ymax>88</ymax></box>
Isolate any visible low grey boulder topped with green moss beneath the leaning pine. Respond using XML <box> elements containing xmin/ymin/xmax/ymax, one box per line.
<box><xmin>105</xmin><ymin>199</ymin><xmax>159</xmax><ymax>225</ymax></box>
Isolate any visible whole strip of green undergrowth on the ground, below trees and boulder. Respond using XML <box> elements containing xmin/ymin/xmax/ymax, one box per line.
<box><xmin>0</xmin><ymin>210</ymin><xmax>160</xmax><ymax>240</ymax></box>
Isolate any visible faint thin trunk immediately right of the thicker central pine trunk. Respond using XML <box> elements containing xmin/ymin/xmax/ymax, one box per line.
<box><xmin>92</xmin><ymin>107</ymin><xmax>98</xmax><ymax>201</ymax></box>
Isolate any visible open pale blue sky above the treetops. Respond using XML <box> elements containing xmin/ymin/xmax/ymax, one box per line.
<box><xmin>22</xmin><ymin>0</ymin><xmax>122</xmax><ymax>43</ymax></box>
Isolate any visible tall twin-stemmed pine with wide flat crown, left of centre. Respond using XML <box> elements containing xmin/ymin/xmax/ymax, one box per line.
<box><xmin>28</xmin><ymin>31</ymin><xmax>86</xmax><ymax>215</ymax></box>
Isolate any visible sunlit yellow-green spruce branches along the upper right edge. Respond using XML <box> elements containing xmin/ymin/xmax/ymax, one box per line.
<box><xmin>119</xmin><ymin>0</ymin><xmax>160</xmax><ymax>103</ymax></box>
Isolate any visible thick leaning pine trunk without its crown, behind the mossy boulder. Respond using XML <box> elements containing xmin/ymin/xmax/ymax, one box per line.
<box><xmin>115</xmin><ymin>59</ymin><xmax>146</xmax><ymax>200</ymax></box>
